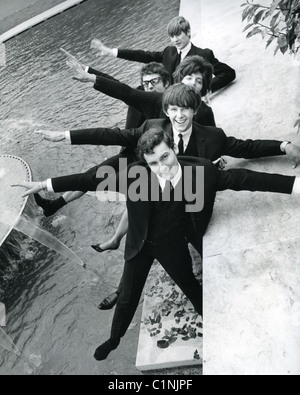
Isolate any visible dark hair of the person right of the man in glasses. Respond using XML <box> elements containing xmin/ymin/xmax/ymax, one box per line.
<box><xmin>173</xmin><ymin>55</ymin><xmax>213</xmax><ymax>96</ymax></box>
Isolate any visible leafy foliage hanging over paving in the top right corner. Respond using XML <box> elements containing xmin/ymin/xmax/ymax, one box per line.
<box><xmin>241</xmin><ymin>0</ymin><xmax>300</xmax><ymax>55</ymax></box>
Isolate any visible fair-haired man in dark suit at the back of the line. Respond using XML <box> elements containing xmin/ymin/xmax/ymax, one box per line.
<box><xmin>92</xmin><ymin>16</ymin><xmax>236</xmax><ymax>92</ymax></box>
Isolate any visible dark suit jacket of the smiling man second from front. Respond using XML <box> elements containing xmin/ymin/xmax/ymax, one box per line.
<box><xmin>71</xmin><ymin>119</ymin><xmax>284</xmax><ymax>161</ymax></box>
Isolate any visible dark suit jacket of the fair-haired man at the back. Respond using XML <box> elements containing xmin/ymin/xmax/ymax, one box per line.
<box><xmin>118</xmin><ymin>44</ymin><xmax>236</xmax><ymax>92</ymax></box>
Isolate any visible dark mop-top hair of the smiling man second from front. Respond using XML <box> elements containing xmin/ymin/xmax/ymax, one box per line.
<box><xmin>162</xmin><ymin>83</ymin><xmax>201</xmax><ymax>112</ymax></box>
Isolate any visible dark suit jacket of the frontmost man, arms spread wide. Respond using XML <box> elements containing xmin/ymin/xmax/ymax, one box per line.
<box><xmin>52</xmin><ymin>157</ymin><xmax>295</xmax><ymax>260</ymax></box>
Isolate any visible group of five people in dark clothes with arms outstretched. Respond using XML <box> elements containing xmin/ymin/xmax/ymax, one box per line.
<box><xmin>14</xmin><ymin>17</ymin><xmax>300</xmax><ymax>361</ymax></box>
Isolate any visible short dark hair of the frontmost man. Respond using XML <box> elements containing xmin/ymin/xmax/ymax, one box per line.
<box><xmin>137</xmin><ymin>128</ymin><xmax>174</xmax><ymax>161</ymax></box>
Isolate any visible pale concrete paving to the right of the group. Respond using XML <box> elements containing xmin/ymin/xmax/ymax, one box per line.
<box><xmin>182</xmin><ymin>0</ymin><xmax>300</xmax><ymax>375</ymax></box>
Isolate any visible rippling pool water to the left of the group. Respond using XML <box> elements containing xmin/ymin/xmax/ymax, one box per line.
<box><xmin>0</xmin><ymin>0</ymin><xmax>179</xmax><ymax>375</ymax></box>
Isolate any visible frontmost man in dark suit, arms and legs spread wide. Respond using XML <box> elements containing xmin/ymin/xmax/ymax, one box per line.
<box><xmin>16</xmin><ymin>128</ymin><xmax>299</xmax><ymax>361</ymax></box>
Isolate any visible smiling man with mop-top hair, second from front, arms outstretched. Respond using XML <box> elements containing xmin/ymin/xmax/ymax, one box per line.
<box><xmin>32</xmin><ymin>84</ymin><xmax>300</xmax><ymax>220</ymax></box>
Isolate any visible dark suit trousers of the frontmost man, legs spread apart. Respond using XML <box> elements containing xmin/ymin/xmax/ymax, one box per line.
<box><xmin>111</xmin><ymin>240</ymin><xmax>203</xmax><ymax>341</ymax></box>
